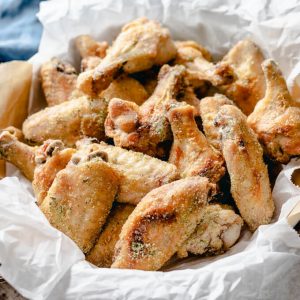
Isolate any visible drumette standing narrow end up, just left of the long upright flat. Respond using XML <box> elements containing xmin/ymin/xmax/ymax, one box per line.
<box><xmin>169</xmin><ymin>105</ymin><xmax>225</xmax><ymax>182</ymax></box>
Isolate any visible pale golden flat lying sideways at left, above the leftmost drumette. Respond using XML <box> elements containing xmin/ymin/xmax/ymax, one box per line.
<box><xmin>23</xmin><ymin>96</ymin><xmax>107</xmax><ymax>146</ymax></box>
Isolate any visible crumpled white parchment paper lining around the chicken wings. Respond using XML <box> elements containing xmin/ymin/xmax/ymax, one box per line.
<box><xmin>0</xmin><ymin>0</ymin><xmax>300</xmax><ymax>300</ymax></box>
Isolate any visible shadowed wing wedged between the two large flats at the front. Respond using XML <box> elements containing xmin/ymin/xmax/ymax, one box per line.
<box><xmin>86</xmin><ymin>204</ymin><xmax>135</xmax><ymax>268</ymax></box>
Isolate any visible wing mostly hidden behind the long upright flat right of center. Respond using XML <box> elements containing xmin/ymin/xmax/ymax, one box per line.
<box><xmin>199</xmin><ymin>94</ymin><xmax>233</xmax><ymax>151</ymax></box>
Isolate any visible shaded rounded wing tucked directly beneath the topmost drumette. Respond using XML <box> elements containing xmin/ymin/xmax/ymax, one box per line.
<box><xmin>101</xmin><ymin>74</ymin><xmax>149</xmax><ymax>105</ymax></box>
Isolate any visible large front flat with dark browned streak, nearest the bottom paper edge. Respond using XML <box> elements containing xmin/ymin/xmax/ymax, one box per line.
<box><xmin>112</xmin><ymin>176</ymin><xmax>215</xmax><ymax>271</ymax></box>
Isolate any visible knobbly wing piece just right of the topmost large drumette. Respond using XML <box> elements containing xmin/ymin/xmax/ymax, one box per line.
<box><xmin>174</xmin><ymin>41</ymin><xmax>234</xmax><ymax>88</ymax></box>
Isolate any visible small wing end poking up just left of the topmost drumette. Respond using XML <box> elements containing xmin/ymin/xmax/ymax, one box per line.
<box><xmin>75</xmin><ymin>34</ymin><xmax>108</xmax><ymax>58</ymax></box>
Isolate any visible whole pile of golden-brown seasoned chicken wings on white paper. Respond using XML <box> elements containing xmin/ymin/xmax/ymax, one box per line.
<box><xmin>0</xmin><ymin>18</ymin><xmax>300</xmax><ymax>270</ymax></box>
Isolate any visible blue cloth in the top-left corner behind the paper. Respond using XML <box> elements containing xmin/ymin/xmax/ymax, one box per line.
<box><xmin>0</xmin><ymin>0</ymin><xmax>42</xmax><ymax>62</ymax></box>
